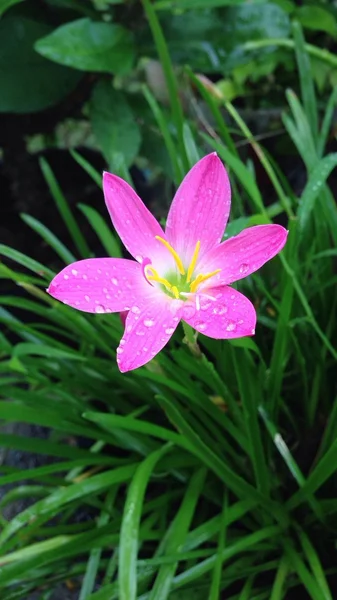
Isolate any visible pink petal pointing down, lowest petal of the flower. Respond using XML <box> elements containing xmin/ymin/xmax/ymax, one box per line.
<box><xmin>117</xmin><ymin>290</ymin><xmax>183</xmax><ymax>373</ymax></box>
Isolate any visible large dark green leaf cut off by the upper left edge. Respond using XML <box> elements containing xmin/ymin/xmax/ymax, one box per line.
<box><xmin>0</xmin><ymin>16</ymin><xmax>80</xmax><ymax>113</ymax></box>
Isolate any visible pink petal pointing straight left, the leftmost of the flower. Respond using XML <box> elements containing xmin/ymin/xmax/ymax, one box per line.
<box><xmin>47</xmin><ymin>258</ymin><xmax>149</xmax><ymax>313</ymax></box>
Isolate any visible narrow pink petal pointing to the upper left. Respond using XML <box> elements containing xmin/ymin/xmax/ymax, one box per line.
<box><xmin>103</xmin><ymin>173</ymin><xmax>170</xmax><ymax>263</ymax></box>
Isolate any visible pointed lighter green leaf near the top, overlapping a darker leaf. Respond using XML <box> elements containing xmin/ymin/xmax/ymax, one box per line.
<box><xmin>35</xmin><ymin>19</ymin><xmax>134</xmax><ymax>75</ymax></box>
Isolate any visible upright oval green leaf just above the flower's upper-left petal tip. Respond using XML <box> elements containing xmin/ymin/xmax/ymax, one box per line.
<box><xmin>90</xmin><ymin>81</ymin><xmax>141</xmax><ymax>170</ymax></box>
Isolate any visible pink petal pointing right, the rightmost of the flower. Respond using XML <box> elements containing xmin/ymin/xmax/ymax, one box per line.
<box><xmin>198</xmin><ymin>225</ymin><xmax>288</xmax><ymax>285</ymax></box>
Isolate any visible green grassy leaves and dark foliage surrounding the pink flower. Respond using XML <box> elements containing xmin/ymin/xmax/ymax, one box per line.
<box><xmin>0</xmin><ymin>0</ymin><xmax>337</xmax><ymax>600</ymax></box>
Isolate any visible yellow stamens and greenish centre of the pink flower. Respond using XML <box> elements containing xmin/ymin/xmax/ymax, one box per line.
<box><xmin>144</xmin><ymin>235</ymin><xmax>221</xmax><ymax>300</ymax></box>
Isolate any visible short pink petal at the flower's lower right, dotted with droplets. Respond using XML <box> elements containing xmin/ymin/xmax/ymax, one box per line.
<box><xmin>182</xmin><ymin>286</ymin><xmax>256</xmax><ymax>339</ymax></box>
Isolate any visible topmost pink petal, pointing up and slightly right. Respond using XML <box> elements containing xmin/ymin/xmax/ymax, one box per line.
<box><xmin>166</xmin><ymin>152</ymin><xmax>231</xmax><ymax>264</ymax></box>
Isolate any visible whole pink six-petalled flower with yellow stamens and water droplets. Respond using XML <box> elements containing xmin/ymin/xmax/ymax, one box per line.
<box><xmin>47</xmin><ymin>153</ymin><xmax>287</xmax><ymax>372</ymax></box>
